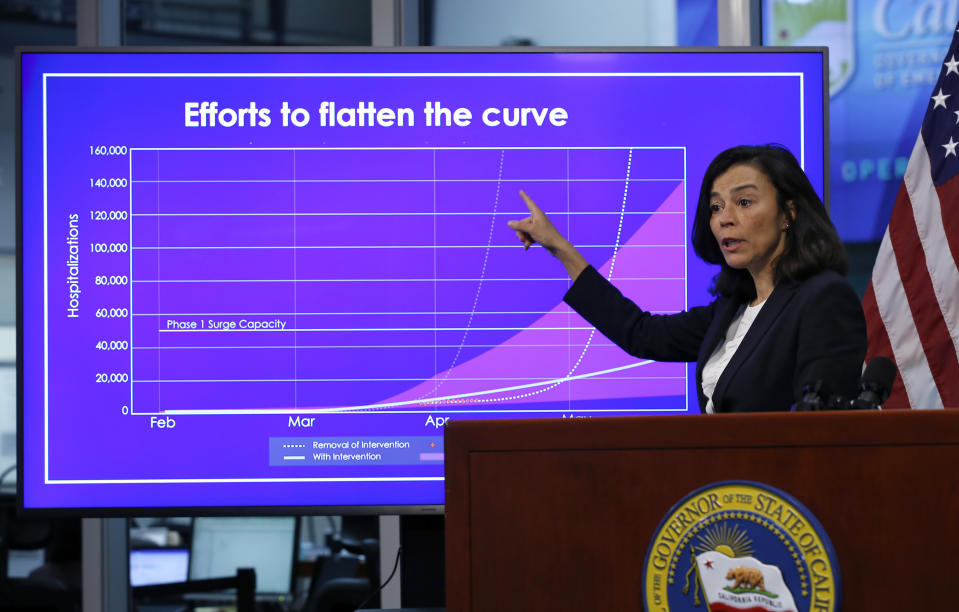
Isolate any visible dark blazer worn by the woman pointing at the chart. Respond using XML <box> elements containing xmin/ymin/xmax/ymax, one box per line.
<box><xmin>564</xmin><ymin>266</ymin><xmax>866</xmax><ymax>412</ymax></box>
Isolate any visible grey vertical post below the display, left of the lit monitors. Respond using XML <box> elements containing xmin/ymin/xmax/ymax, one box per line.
<box><xmin>82</xmin><ymin>518</ymin><xmax>130</xmax><ymax>612</ymax></box>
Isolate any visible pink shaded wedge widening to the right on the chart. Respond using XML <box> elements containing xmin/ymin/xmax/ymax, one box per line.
<box><xmin>372</xmin><ymin>184</ymin><xmax>685</xmax><ymax>406</ymax></box>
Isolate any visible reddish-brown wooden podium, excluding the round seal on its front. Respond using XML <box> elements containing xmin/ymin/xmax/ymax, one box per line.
<box><xmin>445</xmin><ymin>411</ymin><xmax>959</xmax><ymax>612</ymax></box>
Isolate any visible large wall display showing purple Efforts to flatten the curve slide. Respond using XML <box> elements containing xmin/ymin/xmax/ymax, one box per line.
<box><xmin>18</xmin><ymin>49</ymin><xmax>825</xmax><ymax>512</ymax></box>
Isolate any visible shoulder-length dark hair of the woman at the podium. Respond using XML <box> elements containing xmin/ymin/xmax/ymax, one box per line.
<box><xmin>692</xmin><ymin>144</ymin><xmax>848</xmax><ymax>300</ymax></box>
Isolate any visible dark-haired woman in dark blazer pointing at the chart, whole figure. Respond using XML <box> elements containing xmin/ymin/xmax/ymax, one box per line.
<box><xmin>509</xmin><ymin>145</ymin><xmax>866</xmax><ymax>413</ymax></box>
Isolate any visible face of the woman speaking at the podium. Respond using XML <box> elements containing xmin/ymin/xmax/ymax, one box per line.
<box><xmin>709</xmin><ymin>164</ymin><xmax>793</xmax><ymax>280</ymax></box>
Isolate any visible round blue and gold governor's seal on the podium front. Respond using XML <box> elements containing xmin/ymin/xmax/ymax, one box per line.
<box><xmin>643</xmin><ymin>481</ymin><xmax>841</xmax><ymax>612</ymax></box>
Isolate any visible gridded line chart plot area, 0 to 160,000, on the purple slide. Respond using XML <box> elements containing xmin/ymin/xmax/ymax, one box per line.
<box><xmin>130</xmin><ymin>147</ymin><xmax>686</xmax><ymax>414</ymax></box>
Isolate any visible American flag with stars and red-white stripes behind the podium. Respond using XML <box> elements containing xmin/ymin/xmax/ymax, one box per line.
<box><xmin>862</xmin><ymin>25</ymin><xmax>959</xmax><ymax>408</ymax></box>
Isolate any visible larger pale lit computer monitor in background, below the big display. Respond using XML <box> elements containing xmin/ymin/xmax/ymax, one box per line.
<box><xmin>189</xmin><ymin>516</ymin><xmax>297</xmax><ymax>596</ymax></box>
